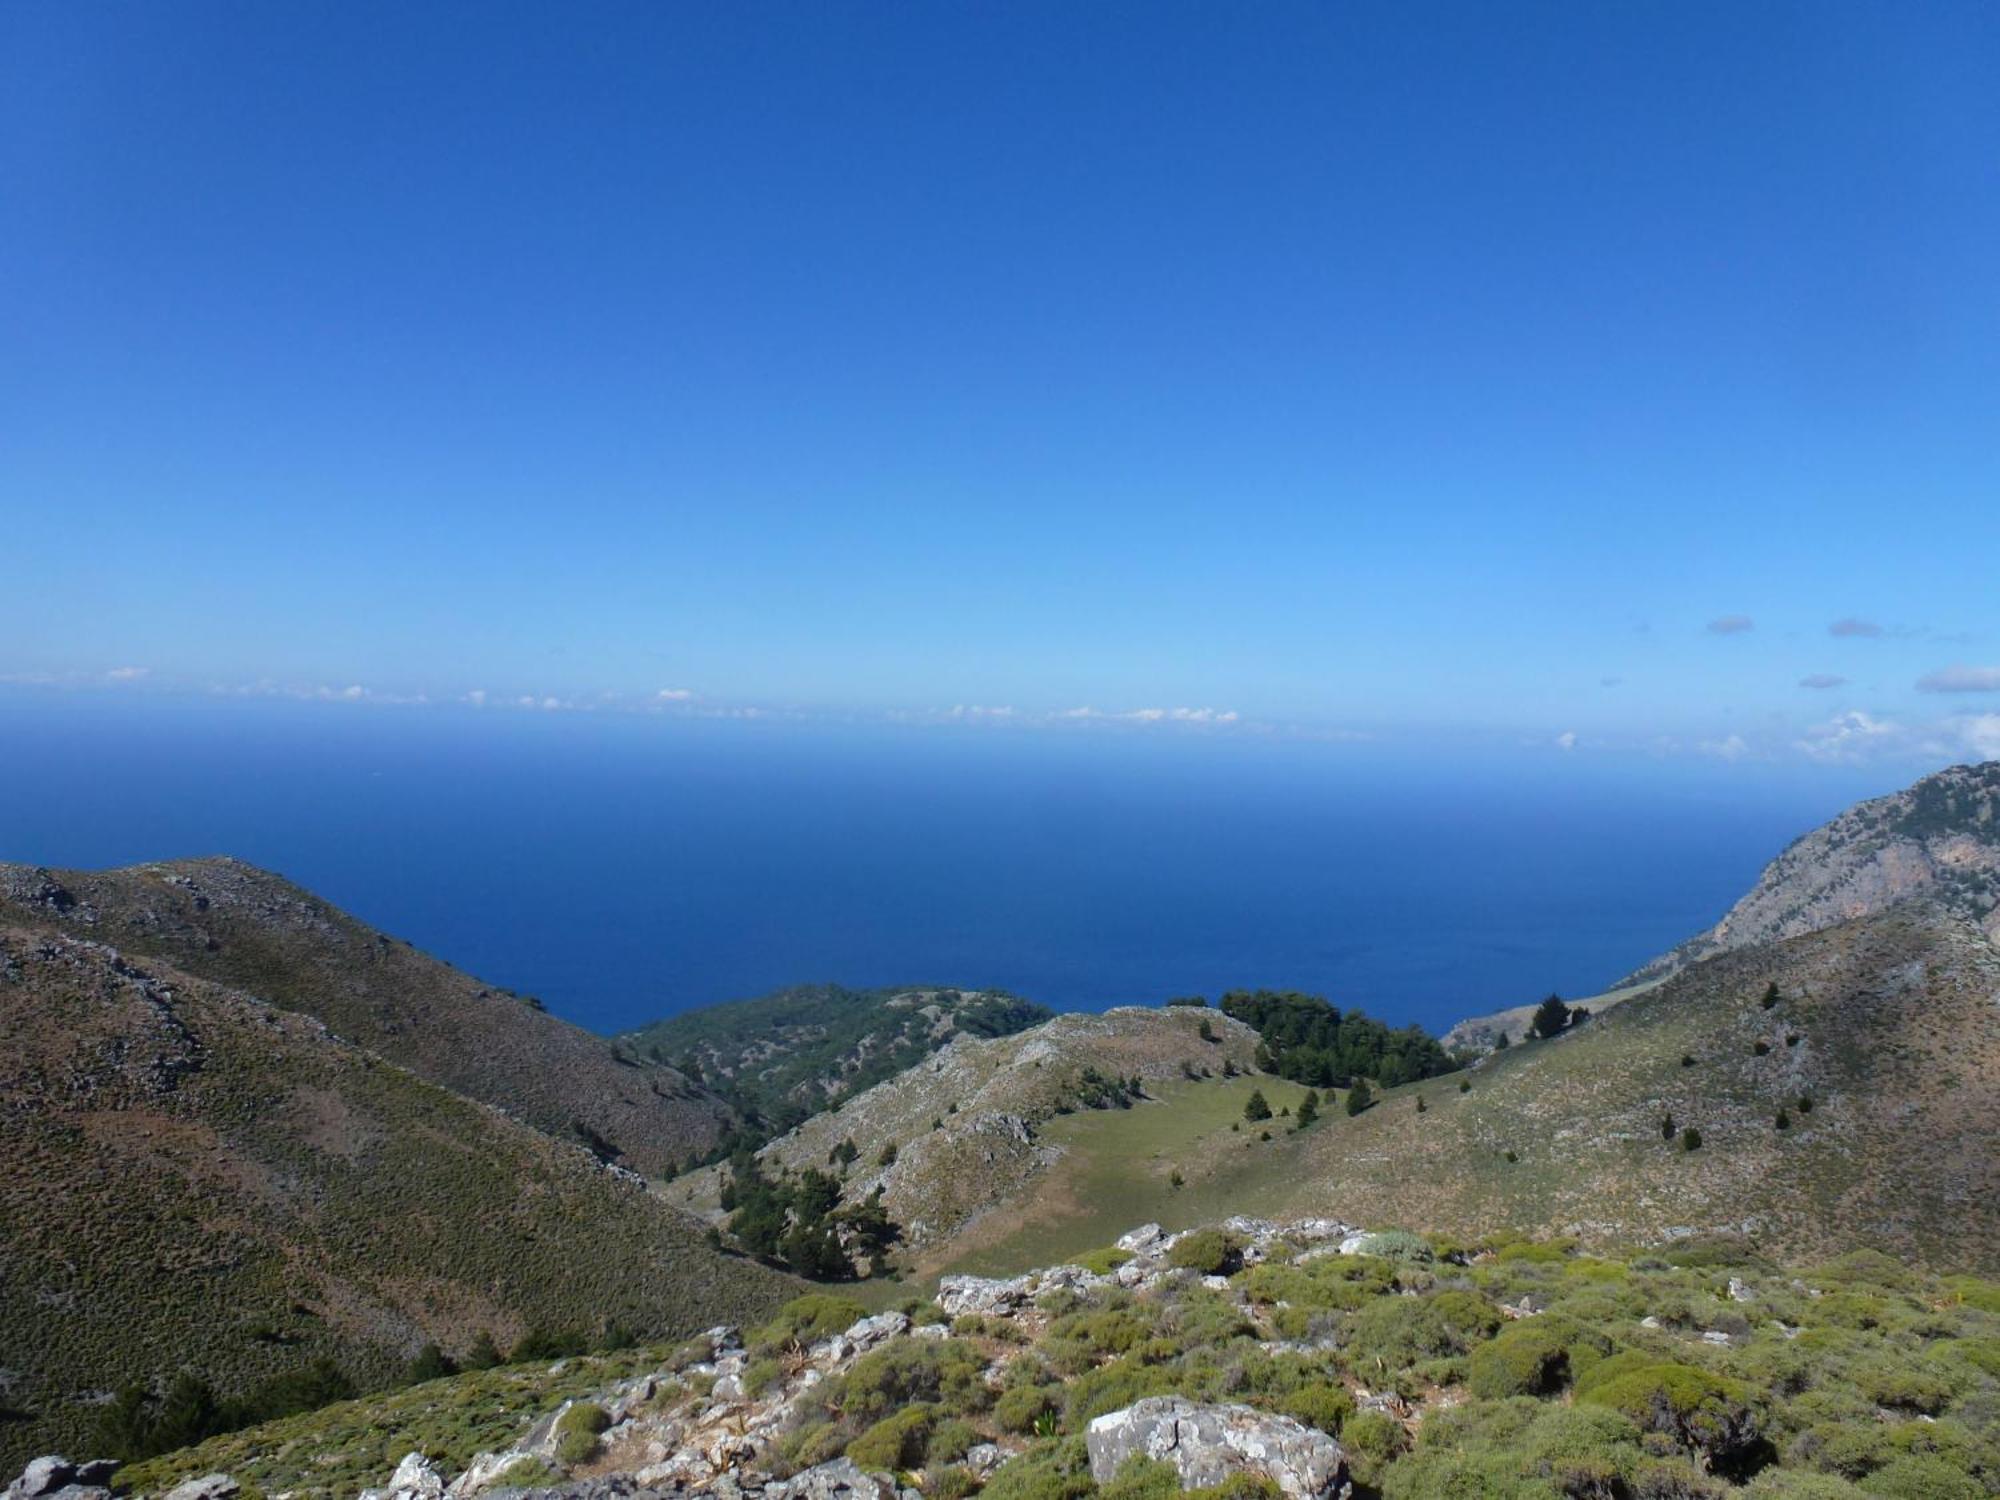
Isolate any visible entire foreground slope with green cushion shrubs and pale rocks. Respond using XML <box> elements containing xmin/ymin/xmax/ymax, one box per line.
<box><xmin>105</xmin><ymin>1220</ymin><xmax>2000</xmax><ymax>1500</ymax></box>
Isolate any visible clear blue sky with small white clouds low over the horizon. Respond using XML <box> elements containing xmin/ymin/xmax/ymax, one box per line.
<box><xmin>0</xmin><ymin>0</ymin><xmax>2000</xmax><ymax>760</ymax></box>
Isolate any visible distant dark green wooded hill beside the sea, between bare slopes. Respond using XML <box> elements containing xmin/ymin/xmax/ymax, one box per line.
<box><xmin>620</xmin><ymin>984</ymin><xmax>1054</xmax><ymax>1134</ymax></box>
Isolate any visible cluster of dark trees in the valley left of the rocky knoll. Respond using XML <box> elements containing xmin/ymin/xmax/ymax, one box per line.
<box><xmin>722</xmin><ymin>1142</ymin><xmax>902</xmax><ymax>1282</ymax></box>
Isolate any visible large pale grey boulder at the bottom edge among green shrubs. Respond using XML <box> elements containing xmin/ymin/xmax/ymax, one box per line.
<box><xmin>1084</xmin><ymin>1396</ymin><xmax>1352</xmax><ymax>1500</ymax></box>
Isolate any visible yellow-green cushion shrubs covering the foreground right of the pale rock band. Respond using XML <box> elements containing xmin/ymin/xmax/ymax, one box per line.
<box><xmin>982</xmin><ymin>1236</ymin><xmax>2000</xmax><ymax>1500</ymax></box>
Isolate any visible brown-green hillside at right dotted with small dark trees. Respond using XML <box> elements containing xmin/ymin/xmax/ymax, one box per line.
<box><xmin>1262</xmin><ymin>904</ymin><xmax>2000</xmax><ymax>1268</ymax></box>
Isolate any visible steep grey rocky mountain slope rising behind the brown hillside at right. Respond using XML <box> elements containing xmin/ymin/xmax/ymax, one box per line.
<box><xmin>1622</xmin><ymin>760</ymin><xmax>2000</xmax><ymax>984</ymax></box>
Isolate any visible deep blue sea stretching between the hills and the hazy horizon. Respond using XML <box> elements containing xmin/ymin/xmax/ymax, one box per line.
<box><xmin>0</xmin><ymin>692</ymin><xmax>1902</xmax><ymax>1030</ymax></box>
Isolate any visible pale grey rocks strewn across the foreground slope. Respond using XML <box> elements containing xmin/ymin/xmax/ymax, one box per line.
<box><xmin>0</xmin><ymin>1218</ymin><xmax>1368</xmax><ymax>1500</ymax></box>
